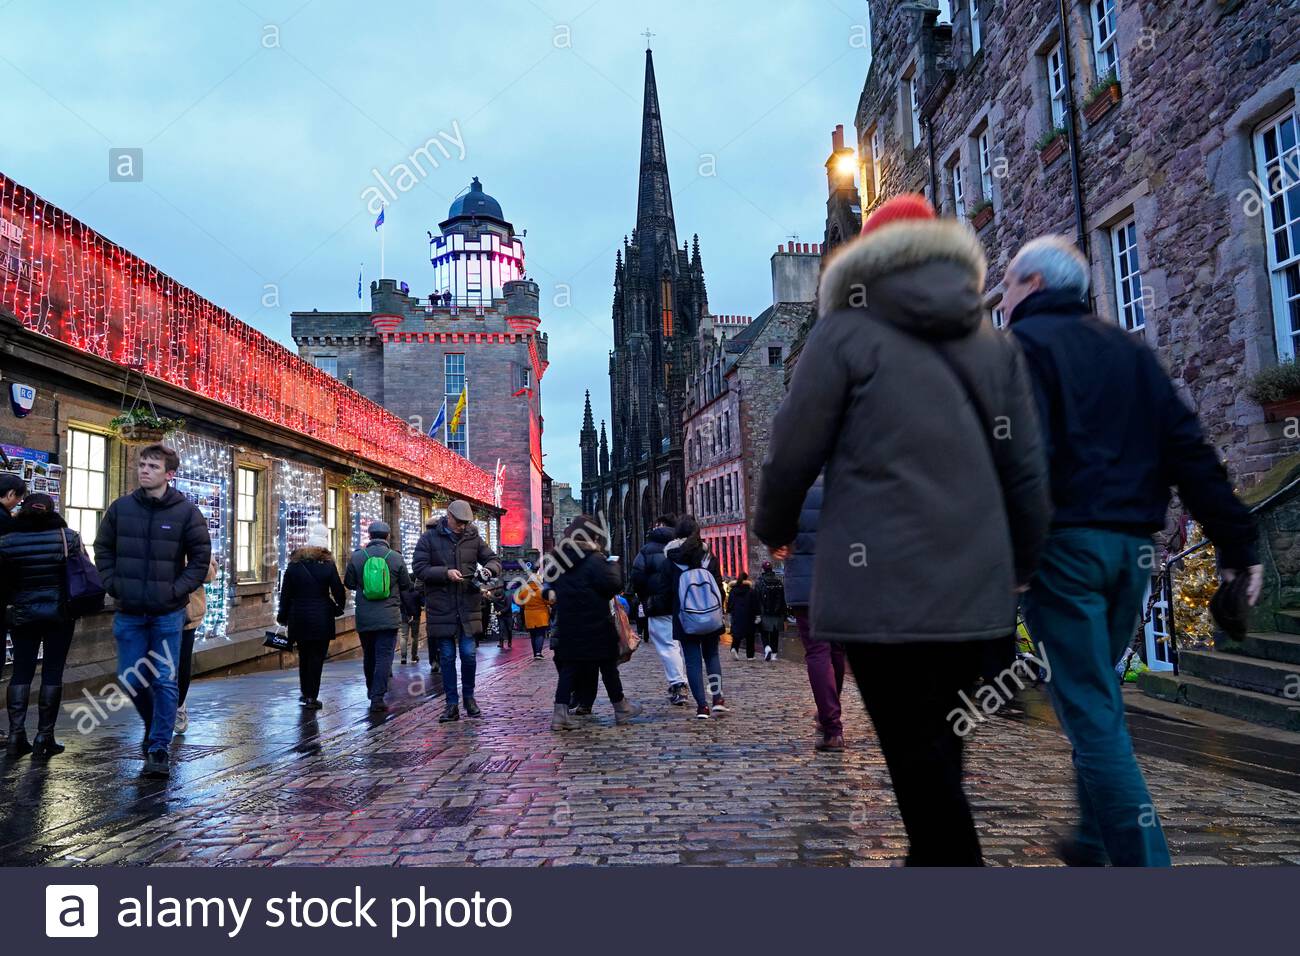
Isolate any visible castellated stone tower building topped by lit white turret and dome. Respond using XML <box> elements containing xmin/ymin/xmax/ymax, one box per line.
<box><xmin>291</xmin><ymin>177</ymin><xmax>547</xmax><ymax>554</ymax></box>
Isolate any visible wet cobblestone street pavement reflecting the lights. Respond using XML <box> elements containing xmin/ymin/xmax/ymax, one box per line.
<box><xmin>0</xmin><ymin>645</ymin><xmax>1300</xmax><ymax>866</ymax></box>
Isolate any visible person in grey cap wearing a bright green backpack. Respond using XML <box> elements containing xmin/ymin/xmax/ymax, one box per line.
<box><xmin>343</xmin><ymin>522</ymin><xmax>413</xmax><ymax>714</ymax></box>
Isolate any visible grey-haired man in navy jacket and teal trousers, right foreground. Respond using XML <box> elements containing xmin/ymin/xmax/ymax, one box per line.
<box><xmin>1002</xmin><ymin>237</ymin><xmax>1262</xmax><ymax>866</ymax></box>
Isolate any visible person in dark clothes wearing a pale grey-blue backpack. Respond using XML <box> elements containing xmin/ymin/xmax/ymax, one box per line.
<box><xmin>663</xmin><ymin>515</ymin><xmax>728</xmax><ymax>721</ymax></box>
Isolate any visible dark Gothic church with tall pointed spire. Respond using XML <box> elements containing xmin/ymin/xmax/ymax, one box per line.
<box><xmin>579</xmin><ymin>49</ymin><xmax>709</xmax><ymax>555</ymax></box>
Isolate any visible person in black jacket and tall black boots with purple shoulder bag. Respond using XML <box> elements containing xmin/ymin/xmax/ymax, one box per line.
<box><xmin>0</xmin><ymin>494</ymin><xmax>82</xmax><ymax>757</ymax></box>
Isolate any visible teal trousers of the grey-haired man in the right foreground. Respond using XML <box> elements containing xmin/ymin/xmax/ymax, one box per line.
<box><xmin>1024</xmin><ymin>528</ymin><xmax>1170</xmax><ymax>866</ymax></box>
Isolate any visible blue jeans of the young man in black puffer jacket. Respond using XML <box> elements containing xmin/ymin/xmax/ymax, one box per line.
<box><xmin>113</xmin><ymin>607</ymin><xmax>185</xmax><ymax>753</ymax></box>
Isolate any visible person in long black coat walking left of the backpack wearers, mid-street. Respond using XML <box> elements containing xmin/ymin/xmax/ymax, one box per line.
<box><xmin>542</xmin><ymin>515</ymin><xmax>641</xmax><ymax>730</ymax></box>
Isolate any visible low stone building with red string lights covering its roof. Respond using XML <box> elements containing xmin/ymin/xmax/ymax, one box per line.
<box><xmin>0</xmin><ymin>174</ymin><xmax>501</xmax><ymax>696</ymax></box>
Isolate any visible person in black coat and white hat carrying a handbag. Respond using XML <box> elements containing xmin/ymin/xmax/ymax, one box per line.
<box><xmin>276</xmin><ymin>524</ymin><xmax>347</xmax><ymax>710</ymax></box>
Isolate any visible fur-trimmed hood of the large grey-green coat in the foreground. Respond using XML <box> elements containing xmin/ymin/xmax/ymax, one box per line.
<box><xmin>818</xmin><ymin>220</ymin><xmax>988</xmax><ymax>338</ymax></box>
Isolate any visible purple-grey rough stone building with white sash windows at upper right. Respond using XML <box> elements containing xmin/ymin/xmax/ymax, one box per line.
<box><xmin>855</xmin><ymin>0</ymin><xmax>1300</xmax><ymax>484</ymax></box>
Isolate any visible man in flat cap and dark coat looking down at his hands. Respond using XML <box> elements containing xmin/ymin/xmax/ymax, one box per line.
<box><xmin>412</xmin><ymin>499</ymin><xmax>501</xmax><ymax>722</ymax></box>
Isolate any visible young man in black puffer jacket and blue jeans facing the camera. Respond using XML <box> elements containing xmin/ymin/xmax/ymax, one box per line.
<box><xmin>95</xmin><ymin>445</ymin><xmax>212</xmax><ymax>777</ymax></box>
